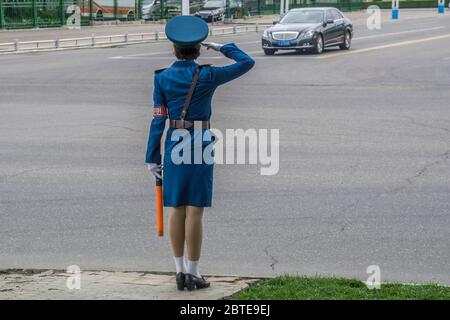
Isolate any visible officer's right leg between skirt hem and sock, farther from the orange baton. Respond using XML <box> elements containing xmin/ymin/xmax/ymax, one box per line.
<box><xmin>185</xmin><ymin>206</ymin><xmax>203</xmax><ymax>261</ymax></box>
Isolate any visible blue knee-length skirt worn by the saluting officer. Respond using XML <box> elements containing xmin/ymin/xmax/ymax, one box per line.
<box><xmin>163</xmin><ymin>128</ymin><xmax>215</xmax><ymax>207</ymax></box>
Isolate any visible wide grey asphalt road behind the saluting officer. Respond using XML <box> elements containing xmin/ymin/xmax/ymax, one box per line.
<box><xmin>0</xmin><ymin>14</ymin><xmax>450</xmax><ymax>284</ymax></box>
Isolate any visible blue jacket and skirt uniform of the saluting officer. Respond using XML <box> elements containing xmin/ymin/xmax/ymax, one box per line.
<box><xmin>146</xmin><ymin>44</ymin><xmax>255</xmax><ymax>207</ymax></box>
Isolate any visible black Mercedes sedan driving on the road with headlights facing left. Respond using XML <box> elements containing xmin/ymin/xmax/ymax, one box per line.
<box><xmin>262</xmin><ymin>8</ymin><xmax>353</xmax><ymax>55</ymax></box>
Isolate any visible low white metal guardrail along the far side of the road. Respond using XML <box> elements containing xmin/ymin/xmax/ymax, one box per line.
<box><xmin>0</xmin><ymin>24</ymin><xmax>269</xmax><ymax>52</ymax></box>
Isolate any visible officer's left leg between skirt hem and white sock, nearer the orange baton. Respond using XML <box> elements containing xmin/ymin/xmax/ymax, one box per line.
<box><xmin>169</xmin><ymin>206</ymin><xmax>186</xmax><ymax>257</ymax></box>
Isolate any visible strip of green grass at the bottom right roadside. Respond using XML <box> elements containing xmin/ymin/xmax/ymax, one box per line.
<box><xmin>230</xmin><ymin>276</ymin><xmax>450</xmax><ymax>300</ymax></box>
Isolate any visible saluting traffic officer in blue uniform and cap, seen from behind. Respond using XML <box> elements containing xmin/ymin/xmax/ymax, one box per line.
<box><xmin>146</xmin><ymin>16</ymin><xmax>255</xmax><ymax>290</ymax></box>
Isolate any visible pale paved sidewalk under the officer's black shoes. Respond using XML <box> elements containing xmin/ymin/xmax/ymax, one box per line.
<box><xmin>0</xmin><ymin>270</ymin><xmax>258</xmax><ymax>300</ymax></box>
